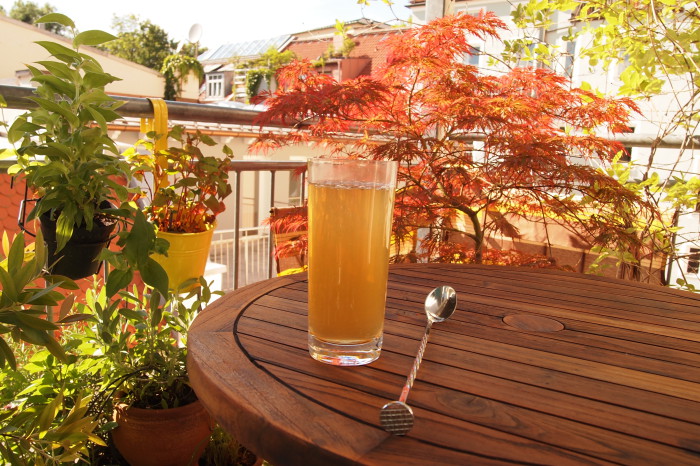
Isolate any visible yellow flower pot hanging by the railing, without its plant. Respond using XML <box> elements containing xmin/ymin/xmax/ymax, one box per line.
<box><xmin>151</xmin><ymin>225</ymin><xmax>216</xmax><ymax>292</ymax></box>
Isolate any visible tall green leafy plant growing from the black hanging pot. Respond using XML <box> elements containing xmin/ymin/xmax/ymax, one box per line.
<box><xmin>8</xmin><ymin>14</ymin><xmax>167</xmax><ymax>294</ymax></box>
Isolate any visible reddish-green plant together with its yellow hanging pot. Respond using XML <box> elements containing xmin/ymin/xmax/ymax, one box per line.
<box><xmin>124</xmin><ymin>126</ymin><xmax>233</xmax><ymax>289</ymax></box>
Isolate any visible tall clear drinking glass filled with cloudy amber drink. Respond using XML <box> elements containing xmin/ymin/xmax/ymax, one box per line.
<box><xmin>308</xmin><ymin>159</ymin><xmax>398</xmax><ymax>366</ymax></box>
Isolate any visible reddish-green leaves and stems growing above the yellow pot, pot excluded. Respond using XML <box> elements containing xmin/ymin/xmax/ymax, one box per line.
<box><xmin>124</xmin><ymin>126</ymin><xmax>233</xmax><ymax>233</ymax></box>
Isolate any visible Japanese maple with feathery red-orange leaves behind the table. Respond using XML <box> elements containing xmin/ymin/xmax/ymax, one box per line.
<box><xmin>253</xmin><ymin>13</ymin><xmax>656</xmax><ymax>274</ymax></box>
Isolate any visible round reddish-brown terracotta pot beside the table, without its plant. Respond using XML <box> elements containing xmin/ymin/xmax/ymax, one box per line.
<box><xmin>112</xmin><ymin>400</ymin><xmax>213</xmax><ymax>466</ymax></box>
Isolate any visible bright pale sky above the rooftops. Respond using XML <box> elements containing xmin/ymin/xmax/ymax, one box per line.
<box><xmin>0</xmin><ymin>0</ymin><xmax>410</xmax><ymax>49</ymax></box>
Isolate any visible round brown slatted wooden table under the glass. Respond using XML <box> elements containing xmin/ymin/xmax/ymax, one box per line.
<box><xmin>188</xmin><ymin>264</ymin><xmax>700</xmax><ymax>466</ymax></box>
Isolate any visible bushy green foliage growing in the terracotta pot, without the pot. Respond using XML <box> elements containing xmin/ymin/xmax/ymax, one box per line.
<box><xmin>84</xmin><ymin>278</ymin><xmax>221</xmax><ymax>409</ymax></box>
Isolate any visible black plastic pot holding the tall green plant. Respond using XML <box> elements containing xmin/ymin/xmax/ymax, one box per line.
<box><xmin>39</xmin><ymin>206</ymin><xmax>117</xmax><ymax>280</ymax></box>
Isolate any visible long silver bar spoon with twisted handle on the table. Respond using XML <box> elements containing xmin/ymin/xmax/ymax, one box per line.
<box><xmin>379</xmin><ymin>286</ymin><xmax>457</xmax><ymax>435</ymax></box>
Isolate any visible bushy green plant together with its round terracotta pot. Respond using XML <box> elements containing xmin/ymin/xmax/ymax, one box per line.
<box><xmin>86</xmin><ymin>278</ymin><xmax>221</xmax><ymax>465</ymax></box>
